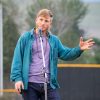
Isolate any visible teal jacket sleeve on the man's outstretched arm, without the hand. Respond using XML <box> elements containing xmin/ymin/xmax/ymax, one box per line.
<box><xmin>58</xmin><ymin>39</ymin><xmax>83</xmax><ymax>60</ymax></box>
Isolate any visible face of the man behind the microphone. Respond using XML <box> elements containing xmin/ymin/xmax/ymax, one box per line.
<box><xmin>35</xmin><ymin>16</ymin><xmax>52</xmax><ymax>31</ymax></box>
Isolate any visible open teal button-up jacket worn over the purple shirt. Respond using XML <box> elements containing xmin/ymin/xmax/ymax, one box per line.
<box><xmin>10</xmin><ymin>29</ymin><xmax>82</xmax><ymax>89</ymax></box>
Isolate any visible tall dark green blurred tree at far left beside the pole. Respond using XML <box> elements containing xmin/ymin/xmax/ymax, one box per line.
<box><xmin>2</xmin><ymin>0</ymin><xmax>19</xmax><ymax>83</ymax></box>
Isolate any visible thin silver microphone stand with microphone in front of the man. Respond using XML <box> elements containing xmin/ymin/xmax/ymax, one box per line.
<box><xmin>39</xmin><ymin>29</ymin><xmax>47</xmax><ymax>100</ymax></box>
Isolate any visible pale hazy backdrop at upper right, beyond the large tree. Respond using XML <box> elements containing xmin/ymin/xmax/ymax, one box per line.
<box><xmin>80</xmin><ymin>0</ymin><xmax>100</xmax><ymax>38</ymax></box>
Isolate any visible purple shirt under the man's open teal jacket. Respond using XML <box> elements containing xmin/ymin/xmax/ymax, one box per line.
<box><xmin>29</xmin><ymin>35</ymin><xmax>50</xmax><ymax>83</ymax></box>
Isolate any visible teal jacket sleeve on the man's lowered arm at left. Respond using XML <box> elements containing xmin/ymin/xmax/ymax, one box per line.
<box><xmin>10</xmin><ymin>37</ymin><xmax>24</xmax><ymax>82</ymax></box>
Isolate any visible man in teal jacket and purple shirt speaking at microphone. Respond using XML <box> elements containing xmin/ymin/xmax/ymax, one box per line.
<box><xmin>11</xmin><ymin>9</ymin><xmax>94</xmax><ymax>100</ymax></box>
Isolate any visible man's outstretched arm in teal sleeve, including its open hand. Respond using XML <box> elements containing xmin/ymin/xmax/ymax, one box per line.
<box><xmin>58</xmin><ymin>38</ymin><xmax>94</xmax><ymax>60</ymax></box>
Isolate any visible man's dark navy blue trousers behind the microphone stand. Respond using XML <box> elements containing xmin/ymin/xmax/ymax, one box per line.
<box><xmin>22</xmin><ymin>82</ymin><xmax>60</xmax><ymax>100</ymax></box>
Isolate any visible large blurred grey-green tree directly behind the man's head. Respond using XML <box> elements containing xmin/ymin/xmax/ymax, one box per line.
<box><xmin>27</xmin><ymin>0</ymin><xmax>87</xmax><ymax>62</ymax></box>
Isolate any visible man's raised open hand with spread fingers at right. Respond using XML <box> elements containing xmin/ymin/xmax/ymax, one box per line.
<box><xmin>79</xmin><ymin>37</ymin><xmax>95</xmax><ymax>50</ymax></box>
